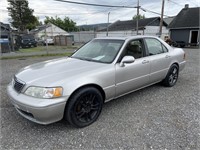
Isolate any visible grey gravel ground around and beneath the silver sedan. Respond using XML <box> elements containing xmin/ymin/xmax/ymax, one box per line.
<box><xmin>0</xmin><ymin>49</ymin><xmax>200</xmax><ymax>150</ymax></box>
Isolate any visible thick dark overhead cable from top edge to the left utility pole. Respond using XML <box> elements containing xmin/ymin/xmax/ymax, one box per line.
<box><xmin>54</xmin><ymin>0</ymin><xmax>137</xmax><ymax>8</ymax></box>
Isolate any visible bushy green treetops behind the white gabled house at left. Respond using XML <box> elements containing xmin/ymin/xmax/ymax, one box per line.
<box><xmin>44</xmin><ymin>16</ymin><xmax>78</xmax><ymax>31</ymax></box>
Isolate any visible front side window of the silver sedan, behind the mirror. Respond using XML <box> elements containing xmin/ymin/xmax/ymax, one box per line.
<box><xmin>125</xmin><ymin>40</ymin><xmax>143</xmax><ymax>59</ymax></box>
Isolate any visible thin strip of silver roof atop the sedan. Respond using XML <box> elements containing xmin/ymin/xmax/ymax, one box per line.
<box><xmin>95</xmin><ymin>35</ymin><xmax>158</xmax><ymax>40</ymax></box>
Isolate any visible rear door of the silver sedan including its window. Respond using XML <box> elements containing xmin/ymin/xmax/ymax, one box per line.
<box><xmin>145</xmin><ymin>38</ymin><xmax>171</xmax><ymax>83</ymax></box>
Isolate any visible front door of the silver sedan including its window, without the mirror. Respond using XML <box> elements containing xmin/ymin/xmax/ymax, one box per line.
<box><xmin>116</xmin><ymin>39</ymin><xmax>150</xmax><ymax>97</ymax></box>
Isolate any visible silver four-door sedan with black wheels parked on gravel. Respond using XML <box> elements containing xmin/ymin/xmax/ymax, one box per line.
<box><xmin>7</xmin><ymin>36</ymin><xmax>186</xmax><ymax>128</ymax></box>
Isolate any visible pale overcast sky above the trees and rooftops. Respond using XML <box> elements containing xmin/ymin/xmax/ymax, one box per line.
<box><xmin>0</xmin><ymin>0</ymin><xmax>200</xmax><ymax>25</ymax></box>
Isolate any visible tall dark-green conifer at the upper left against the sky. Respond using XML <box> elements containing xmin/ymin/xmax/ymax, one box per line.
<box><xmin>7</xmin><ymin>0</ymin><xmax>39</xmax><ymax>32</ymax></box>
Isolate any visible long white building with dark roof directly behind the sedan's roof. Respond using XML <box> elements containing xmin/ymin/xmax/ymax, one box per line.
<box><xmin>96</xmin><ymin>17</ymin><xmax>169</xmax><ymax>37</ymax></box>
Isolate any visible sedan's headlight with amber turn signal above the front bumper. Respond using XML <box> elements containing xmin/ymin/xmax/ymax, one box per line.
<box><xmin>25</xmin><ymin>87</ymin><xmax>63</xmax><ymax>98</ymax></box>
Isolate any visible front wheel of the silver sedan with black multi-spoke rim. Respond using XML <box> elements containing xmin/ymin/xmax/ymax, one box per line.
<box><xmin>65</xmin><ymin>87</ymin><xmax>103</xmax><ymax>128</ymax></box>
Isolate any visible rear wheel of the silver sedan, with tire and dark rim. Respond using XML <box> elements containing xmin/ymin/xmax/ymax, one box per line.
<box><xmin>163</xmin><ymin>64</ymin><xmax>179</xmax><ymax>87</ymax></box>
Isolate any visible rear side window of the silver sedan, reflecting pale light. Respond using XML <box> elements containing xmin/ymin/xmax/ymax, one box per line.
<box><xmin>145</xmin><ymin>38</ymin><xmax>168</xmax><ymax>55</ymax></box>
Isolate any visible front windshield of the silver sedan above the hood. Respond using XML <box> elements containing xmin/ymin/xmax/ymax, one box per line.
<box><xmin>72</xmin><ymin>39</ymin><xmax>124</xmax><ymax>63</ymax></box>
